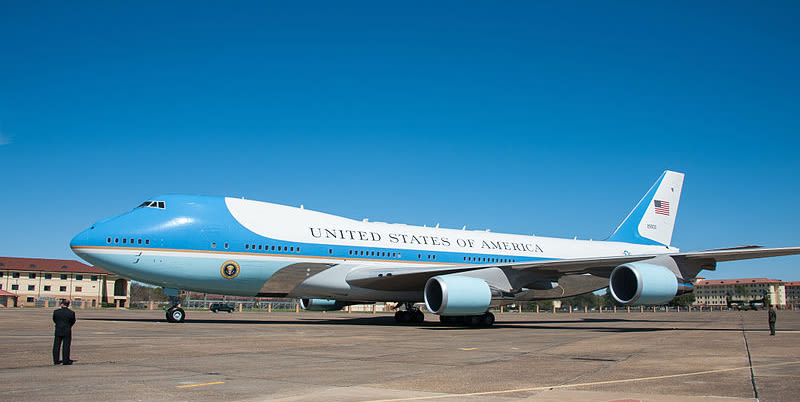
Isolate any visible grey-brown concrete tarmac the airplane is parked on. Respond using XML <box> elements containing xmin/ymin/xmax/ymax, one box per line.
<box><xmin>0</xmin><ymin>309</ymin><xmax>800</xmax><ymax>402</ymax></box>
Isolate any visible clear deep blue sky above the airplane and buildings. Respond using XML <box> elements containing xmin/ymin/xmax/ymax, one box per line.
<box><xmin>0</xmin><ymin>1</ymin><xmax>800</xmax><ymax>280</ymax></box>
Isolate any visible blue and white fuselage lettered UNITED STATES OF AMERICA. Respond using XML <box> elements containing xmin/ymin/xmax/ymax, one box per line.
<box><xmin>70</xmin><ymin>195</ymin><xmax>678</xmax><ymax>301</ymax></box>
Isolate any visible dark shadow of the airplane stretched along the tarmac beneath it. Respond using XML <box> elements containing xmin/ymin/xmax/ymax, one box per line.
<box><xmin>81</xmin><ymin>317</ymin><xmax>742</xmax><ymax>333</ymax></box>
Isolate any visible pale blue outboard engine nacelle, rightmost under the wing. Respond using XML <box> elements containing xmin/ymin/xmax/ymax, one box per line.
<box><xmin>608</xmin><ymin>262</ymin><xmax>682</xmax><ymax>306</ymax></box>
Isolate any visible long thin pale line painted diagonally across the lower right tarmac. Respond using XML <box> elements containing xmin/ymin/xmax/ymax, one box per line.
<box><xmin>368</xmin><ymin>360</ymin><xmax>800</xmax><ymax>402</ymax></box>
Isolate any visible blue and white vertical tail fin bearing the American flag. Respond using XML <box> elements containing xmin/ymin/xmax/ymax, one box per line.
<box><xmin>607</xmin><ymin>170</ymin><xmax>683</xmax><ymax>246</ymax></box>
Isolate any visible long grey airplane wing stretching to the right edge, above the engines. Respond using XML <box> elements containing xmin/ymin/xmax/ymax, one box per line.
<box><xmin>346</xmin><ymin>246</ymin><xmax>800</xmax><ymax>290</ymax></box>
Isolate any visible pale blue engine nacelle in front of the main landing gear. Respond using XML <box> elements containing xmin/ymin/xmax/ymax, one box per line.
<box><xmin>425</xmin><ymin>275</ymin><xmax>492</xmax><ymax>315</ymax></box>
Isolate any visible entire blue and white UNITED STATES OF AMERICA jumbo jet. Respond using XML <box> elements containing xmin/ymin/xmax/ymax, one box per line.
<box><xmin>70</xmin><ymin>171</ymin><xmax>800</xmax><ymax>326</ymax></box>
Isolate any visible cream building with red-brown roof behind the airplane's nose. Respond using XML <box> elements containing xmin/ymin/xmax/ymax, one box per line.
<box><xmin>0</xmin><ymin>257</ymin><xmax>131</xmax><ymax>307</ymax></box>
